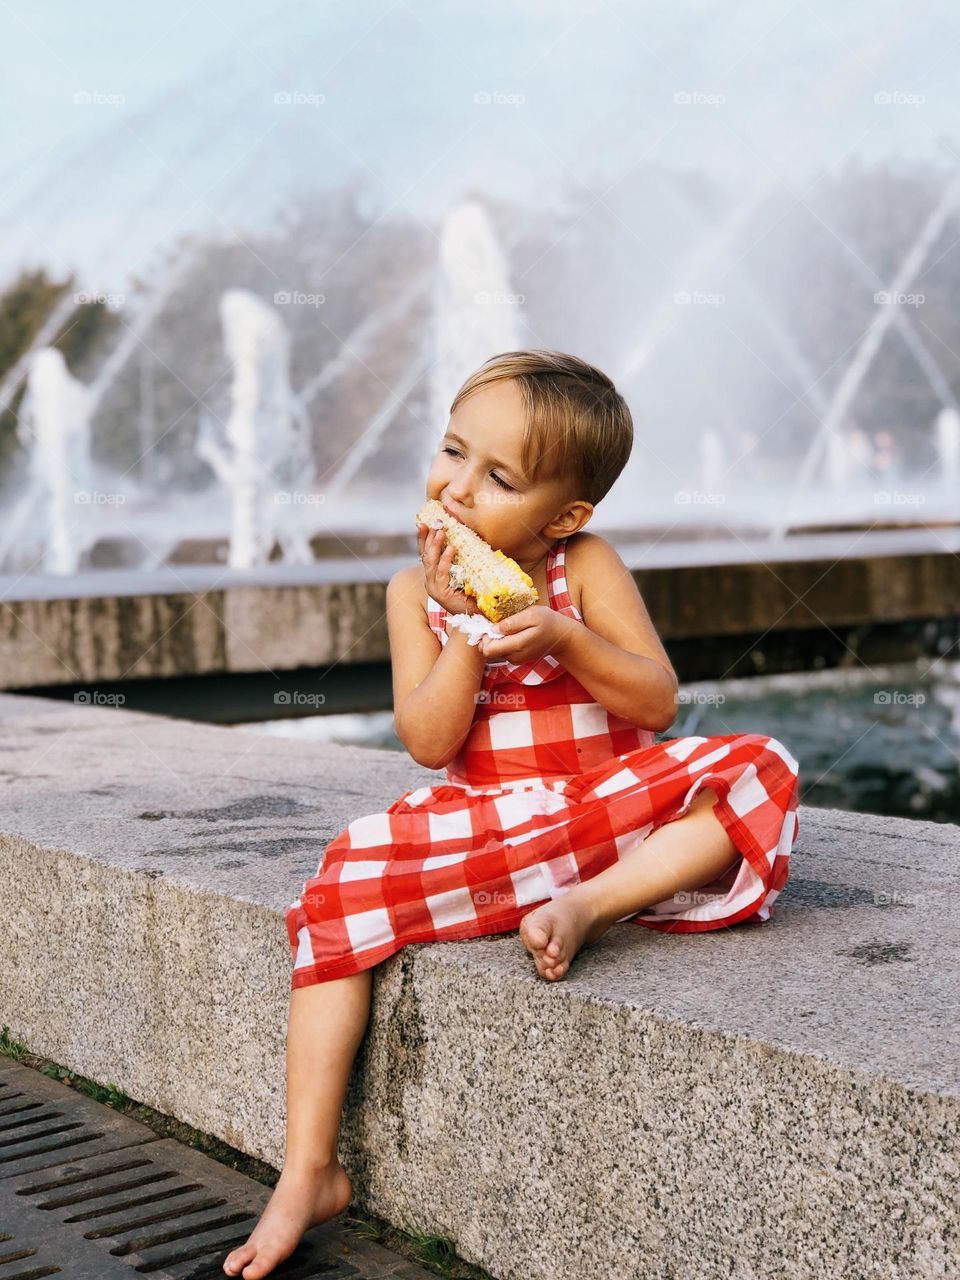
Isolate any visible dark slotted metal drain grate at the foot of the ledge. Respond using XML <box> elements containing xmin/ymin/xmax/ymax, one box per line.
<box><xmin>0</xmin><ymin>1059</ymin><xmax>430</xmax><ymax>1280</ymax></box>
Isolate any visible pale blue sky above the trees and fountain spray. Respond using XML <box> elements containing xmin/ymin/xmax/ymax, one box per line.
<box><xmin>0</xmin><ymin>0</ymin><xmax>960</xmax><ymax>292</ymax></box>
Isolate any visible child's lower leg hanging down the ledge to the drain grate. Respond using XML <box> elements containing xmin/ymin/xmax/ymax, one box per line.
<box><xmin>223</xmin><ymin>969</ymin><xmax>374</xmax><ymax>1280</ymax></box>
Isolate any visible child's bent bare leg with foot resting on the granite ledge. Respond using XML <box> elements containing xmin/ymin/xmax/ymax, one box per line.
<box><xmin>520</xmin><ymin>787</ymin><xmax>741</xmax><ymax>980</ymax></box>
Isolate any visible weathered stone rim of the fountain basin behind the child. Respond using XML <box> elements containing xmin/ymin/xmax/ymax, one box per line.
<box><xmin>0</xmin><ymin>529</ymin><xmax>960</xmax><ymax>689</ymax></box>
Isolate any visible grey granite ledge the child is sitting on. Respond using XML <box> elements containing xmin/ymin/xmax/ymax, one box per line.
<box><xmin>0</xmin><ymin>695</ymin><xmax>960</xmax><ymax>1280</ymax></box>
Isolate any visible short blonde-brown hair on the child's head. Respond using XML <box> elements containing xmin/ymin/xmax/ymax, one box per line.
<box><xmin>451</xmin><ymin>351</ymin><xmax>634</xmax><ymax>504</ymax></box>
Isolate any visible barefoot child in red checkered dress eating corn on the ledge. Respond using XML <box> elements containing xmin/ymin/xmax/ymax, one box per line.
<box><xmin>224</xmin><ymin>351</ymin><xmax>799</xmax><ymax>1280</ymax></box>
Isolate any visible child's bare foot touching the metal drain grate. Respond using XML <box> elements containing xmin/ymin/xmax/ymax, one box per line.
<box><xmin>223</xmin><ymin>1161</ymin><xmax>353</xmax><ymax>1280</ymax></box>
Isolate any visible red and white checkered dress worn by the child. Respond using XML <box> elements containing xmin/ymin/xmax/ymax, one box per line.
<box><xmin>287</xmin><ymin>540</ymin><xmax>800</xmax><ymax>987</ymax></box>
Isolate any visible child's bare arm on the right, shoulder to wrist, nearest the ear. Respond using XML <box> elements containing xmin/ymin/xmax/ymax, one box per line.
<box><xmin>554</xmin><ymin>534</ymin><xmax>680</xmax><ymax>732</ymax></box>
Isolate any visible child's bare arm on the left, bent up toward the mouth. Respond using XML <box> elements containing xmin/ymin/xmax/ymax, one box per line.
<box><xmin>387</xmin><ymin>566</ymin><xmax>486</xmax><ymax>769</ymax></box>
